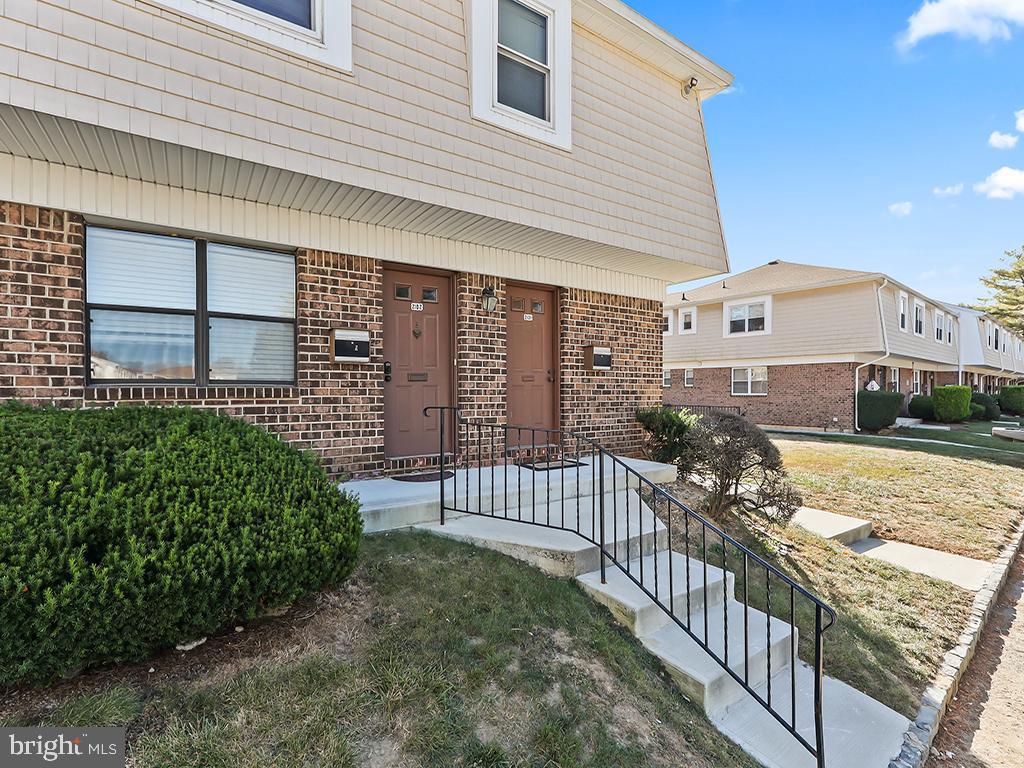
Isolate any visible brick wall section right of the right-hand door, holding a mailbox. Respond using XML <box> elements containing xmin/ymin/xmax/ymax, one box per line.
<box><xmin>559</xmin><ymin>289</ymin><xmax>664</xmax><ymax>455</ymax></box>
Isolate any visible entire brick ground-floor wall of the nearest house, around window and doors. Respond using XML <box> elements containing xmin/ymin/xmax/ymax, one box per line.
<box><xmin>0</xmin><ymin>203</ymin><xmax>662</xmax><ymax>476</ymax></box>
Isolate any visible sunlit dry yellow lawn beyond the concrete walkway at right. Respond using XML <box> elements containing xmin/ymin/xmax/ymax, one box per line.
<box><xmin>773</xmin><ymin>435</ymin><xmax>1024</xmax><ymax>560</ymax></box>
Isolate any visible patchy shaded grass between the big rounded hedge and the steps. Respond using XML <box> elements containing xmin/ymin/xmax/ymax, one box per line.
<box><xmin>0</xmin><ymin>534</ymin><xmax>756</xmax><ymax>768</ymax></box>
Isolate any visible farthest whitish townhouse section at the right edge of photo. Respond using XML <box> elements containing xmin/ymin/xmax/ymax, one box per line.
<box><xmin>945</xmin><ymin>304</ymin><xmax>1024</xmax><ymax>394</ymax></box>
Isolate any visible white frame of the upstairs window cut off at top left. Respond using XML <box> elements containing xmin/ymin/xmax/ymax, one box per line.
<box><xmin>147</xmin><ymin>0</ymin><xmax>352</xmax><ymax>74</ymax></box>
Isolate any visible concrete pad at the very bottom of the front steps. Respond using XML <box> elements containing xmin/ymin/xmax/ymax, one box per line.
<box><xmin>711</xmin><ymin>663</ymin><xmax>910</xmax><ymax>768</ymax></box>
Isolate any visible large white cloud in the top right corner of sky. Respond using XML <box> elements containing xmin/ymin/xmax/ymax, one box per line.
<box><xmin>896</xmin><ymin>0</ymin><xmax>1024</xmax><ymax>50</ymax></box>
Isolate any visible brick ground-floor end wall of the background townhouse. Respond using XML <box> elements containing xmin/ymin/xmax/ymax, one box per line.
<box><xmin>662</xmin><ymin>362</ymin><xmax>856</xmax><ymax>430</ymax></box>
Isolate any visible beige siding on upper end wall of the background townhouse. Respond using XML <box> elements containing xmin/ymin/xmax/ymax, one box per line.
<box><xmin>665</xmin><ymin>283</ymin><xmax>882</xmax><ymax>362</ymax></box>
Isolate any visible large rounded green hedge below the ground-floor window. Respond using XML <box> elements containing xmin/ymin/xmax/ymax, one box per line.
<box><xmin>0</xmin><ymin>403</ymin><xmax>362</xmax><ymax>684</ymax></box>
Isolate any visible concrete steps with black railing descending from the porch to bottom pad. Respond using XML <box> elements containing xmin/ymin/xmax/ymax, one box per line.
<box><xmin>405</xmin><ymin>468</ymin><xmax>909</xmax><ymax>768</ymax></box>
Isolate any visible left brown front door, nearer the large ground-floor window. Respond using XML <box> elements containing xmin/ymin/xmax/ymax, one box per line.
<box><xmin>384</xmin><ymin>269</ymin><xmax>453</xmax><ymax>458</ymax></box>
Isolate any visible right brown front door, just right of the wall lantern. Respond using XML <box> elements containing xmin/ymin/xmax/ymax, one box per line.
<box><xmin>507</xmin><ymin>285</ymin><xmax>558</xmax><ymax>440</ymax></box>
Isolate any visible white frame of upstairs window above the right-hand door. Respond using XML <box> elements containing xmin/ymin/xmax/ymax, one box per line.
<box><xmin>468</xmin><ymin>0</ymin><xmax>572</xmax><ymax>150</ymax></box>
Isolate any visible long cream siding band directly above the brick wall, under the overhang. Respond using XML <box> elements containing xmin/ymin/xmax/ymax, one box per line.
<box><xmin>0</xmin><ymin>155</ymin><xmax>665</xmax><ymax>300</ymax></box>
